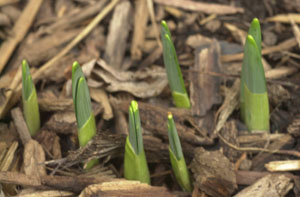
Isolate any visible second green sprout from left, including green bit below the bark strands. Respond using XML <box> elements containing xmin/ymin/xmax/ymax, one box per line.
<box><xmin>72</xmin><ymin>62</ymin><xmax>98</xmax><ymax>170</ymax></box>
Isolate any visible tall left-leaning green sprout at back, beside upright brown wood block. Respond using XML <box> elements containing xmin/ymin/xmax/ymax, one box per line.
<box><xmin>161</xmin><ymin>21</ymin><xmax>191</xmax><ymax>108</ymax></box>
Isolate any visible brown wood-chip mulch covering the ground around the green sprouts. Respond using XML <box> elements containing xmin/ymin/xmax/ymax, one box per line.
<box><xmin>0</xmin><ymin>0</ymin><xmax>300</xmax><ymax>197</ymax></box>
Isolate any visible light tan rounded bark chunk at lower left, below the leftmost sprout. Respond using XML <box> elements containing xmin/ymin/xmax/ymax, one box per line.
<box><xmin>23</xmin><ymin>140</ymin><xmax>47</xmax><ymax>177</ymax></box>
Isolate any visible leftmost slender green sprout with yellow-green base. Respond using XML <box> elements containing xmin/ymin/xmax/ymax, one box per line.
<box><xmin>22</xmin><ymin>60</ymin><xmax>41</xmax><ymax>136</ymax></box>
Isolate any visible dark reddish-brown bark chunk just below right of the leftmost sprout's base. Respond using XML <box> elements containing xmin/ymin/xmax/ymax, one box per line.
<box><xmin>36</xmin><ymin>130</ymin><xmax>61</xmax><ymax>159</ymax></box>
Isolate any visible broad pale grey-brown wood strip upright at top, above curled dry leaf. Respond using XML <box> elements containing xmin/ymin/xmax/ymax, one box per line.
<box><xmin>104</xmin><ymin>0</ymin><xmax>132</xmax><ymax>69</ymax></box>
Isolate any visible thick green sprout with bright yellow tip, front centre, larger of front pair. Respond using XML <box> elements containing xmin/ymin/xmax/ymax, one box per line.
<box><xmin>124</xmin><ymin>100</ymin><xmax>150</xmax><ymax>184</ymax></box>
